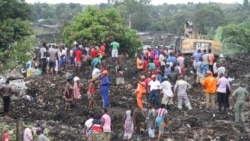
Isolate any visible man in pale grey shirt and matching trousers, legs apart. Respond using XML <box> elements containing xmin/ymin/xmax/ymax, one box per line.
<box><xmin>174</xmin><ymin>75</ymin><xmax>193</xmax><ymax>110</ymax></box>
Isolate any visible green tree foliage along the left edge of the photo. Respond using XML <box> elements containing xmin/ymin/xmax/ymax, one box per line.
<box><xmin>0</xmin><ymin>0</ymin><xmax>32</xmax><ymax>69</ymax></box>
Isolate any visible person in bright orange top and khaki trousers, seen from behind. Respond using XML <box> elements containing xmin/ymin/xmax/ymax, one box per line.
<box><xmin>201</xmin><ymin>71</ymin><xmax>217</xmax><ymax>110</ymax></box>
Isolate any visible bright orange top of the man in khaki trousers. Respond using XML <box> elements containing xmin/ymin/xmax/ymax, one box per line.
<box><xmin>201</xmin><ymin>76</ymin><xmax>218</xmax><ymax>94</ymax></box>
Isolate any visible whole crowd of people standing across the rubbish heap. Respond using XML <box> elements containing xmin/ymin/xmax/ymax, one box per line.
<box><xmin>1</xmin><ymin>41</ymin><xmax>249</xmax><ymax>141</ymax></box>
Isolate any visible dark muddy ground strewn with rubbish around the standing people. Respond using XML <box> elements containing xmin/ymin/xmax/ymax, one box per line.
<box><xmin>1</xmin><ymin>56</ymin><xmax>250</xmax><ymax>141</ymax></box>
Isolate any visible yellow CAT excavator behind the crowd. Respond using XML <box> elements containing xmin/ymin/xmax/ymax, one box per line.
<box><xmin>175</xmin><ymin>21</ymin><xmax>221</xmax><ymax>56</ymax></box>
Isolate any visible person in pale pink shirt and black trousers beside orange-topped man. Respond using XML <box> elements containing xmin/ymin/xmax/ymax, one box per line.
<box><xmin>217</xmin><ymin>73</ymin><xmax>231</xmax><ymax>112</ymax></box>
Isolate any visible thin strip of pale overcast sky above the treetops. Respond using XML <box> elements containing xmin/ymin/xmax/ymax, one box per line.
<box><xmin>26</xmin><ymin>0</ymin><xmax>242</xmax><ymax>5</ymax></box>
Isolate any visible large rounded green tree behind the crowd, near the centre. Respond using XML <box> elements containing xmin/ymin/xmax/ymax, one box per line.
<box><xmin>63</xmin><ymin>7</ymin><xmax>142</xmax><ymax>53</ymax></box>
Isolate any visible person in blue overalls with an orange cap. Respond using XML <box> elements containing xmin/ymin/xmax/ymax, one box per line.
<box><xmin>101</xmin><ymin>70</ymin><xmax>110</xmax><ymax>108</ymax></box>
